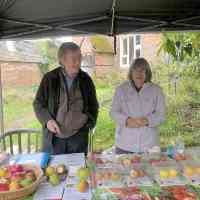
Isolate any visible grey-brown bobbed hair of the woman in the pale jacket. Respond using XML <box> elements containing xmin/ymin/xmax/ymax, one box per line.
<box><xmin>128</xmin><ymin>58</ymin><xmax>152</xmax><ymax>82</ymax></box>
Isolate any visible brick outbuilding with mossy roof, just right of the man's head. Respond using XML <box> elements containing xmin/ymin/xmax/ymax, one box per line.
<box><xmin>72</xmin><ymin>35</ymin><xmax>114</xmax><ymax>76</ymax></box>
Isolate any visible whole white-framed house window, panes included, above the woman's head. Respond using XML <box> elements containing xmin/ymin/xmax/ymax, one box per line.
<box><xmin>120</xmin><ymin>35</ymin><xmax>141</xmax><ymax>67</ymax></box>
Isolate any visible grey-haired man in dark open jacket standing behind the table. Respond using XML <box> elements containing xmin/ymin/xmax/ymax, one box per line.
<box><xmin>33</xmin><ymin>42</ymin><xmax>98</xmax><ymax>154</ymax></box>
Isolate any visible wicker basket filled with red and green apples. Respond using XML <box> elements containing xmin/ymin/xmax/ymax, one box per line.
<box><xmin>0</xmin><ymin>164</ymin><xmax>43</xmax><ymax>200</ymax></box>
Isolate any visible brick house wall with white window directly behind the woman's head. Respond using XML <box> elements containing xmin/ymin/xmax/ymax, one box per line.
<box><xmin>115</xmin><ymin>33</ymin><xmax>161</xmax><ymax>69</ymax></box>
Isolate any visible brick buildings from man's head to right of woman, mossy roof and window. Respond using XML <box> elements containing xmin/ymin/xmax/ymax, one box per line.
<box><xmin>72</xmin><ymin>33</ymin><xmax>161</xmax><ymax>76</ymax></box>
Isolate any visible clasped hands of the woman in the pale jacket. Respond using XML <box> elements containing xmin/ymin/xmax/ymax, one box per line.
<box><xmin>126</xmin><ymin>117</ymin><xmax>148</xmax><ymax>128</ymax></box>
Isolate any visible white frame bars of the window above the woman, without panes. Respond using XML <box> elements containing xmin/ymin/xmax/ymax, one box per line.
<box><xmin>120</xmin><ymin>34</ymin><xmax>142</xmax><ymax>68</ymax></box>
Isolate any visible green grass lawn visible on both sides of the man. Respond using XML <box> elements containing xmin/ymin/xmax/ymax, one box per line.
<box><xmin>1</xmin><ymin>84</ymin><xmax>114</xmax><ymax>150</ymax></box>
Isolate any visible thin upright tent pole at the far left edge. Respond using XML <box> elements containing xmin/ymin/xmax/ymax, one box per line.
<box><xmin>0</xmin><ymin>63</ymin><xmax>6</xmax><ymax>151</ymax></box>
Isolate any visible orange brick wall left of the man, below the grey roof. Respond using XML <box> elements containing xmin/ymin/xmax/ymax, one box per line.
<box><xmin>1</xmin><ymin>62</ymin><xmax>41</xmax><ymax>87</ymax></box>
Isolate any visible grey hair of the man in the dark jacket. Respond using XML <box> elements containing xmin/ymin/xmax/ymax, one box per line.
<box><xmin>57</xmin><ymin>42</ymin><xmax>80</xmax><ymax>64</ymax></box>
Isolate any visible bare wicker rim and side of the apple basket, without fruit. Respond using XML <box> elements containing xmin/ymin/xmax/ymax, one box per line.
<box><xmin>0</xmin><ymin>165</ymin><xmax>43</xmax><ymax>200</ymax></box>
